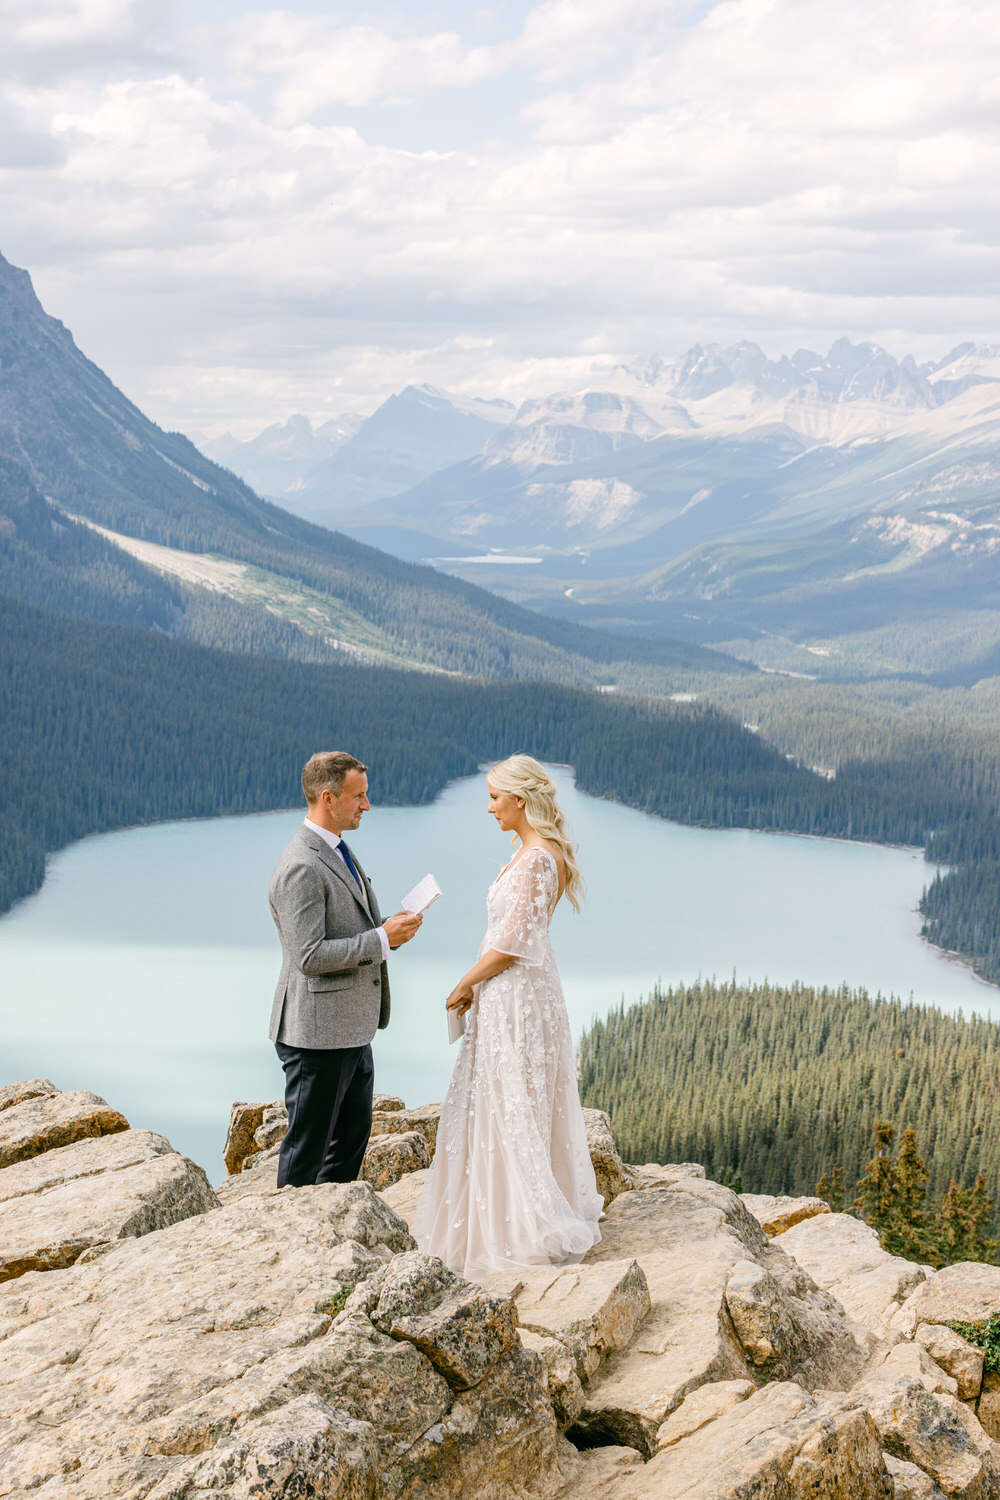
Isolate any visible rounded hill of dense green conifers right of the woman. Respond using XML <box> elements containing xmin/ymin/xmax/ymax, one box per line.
<box><xmin>580</xmin><ymin>981</ymin><xmax>1000</xmax><ymax>1223</ymax></box>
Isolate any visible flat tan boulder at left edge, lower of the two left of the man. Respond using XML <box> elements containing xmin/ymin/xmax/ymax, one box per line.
<box><xmin>0</xmin><ymin>1130</ymin><xmax>219</xmax><ymax>1281</ymax></box>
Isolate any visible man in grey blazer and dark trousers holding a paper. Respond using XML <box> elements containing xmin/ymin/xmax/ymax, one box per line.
<box><xmin>268</xmin><ymin>750</ymin><xmax>423</xmax><ymax>1188</ymax></box>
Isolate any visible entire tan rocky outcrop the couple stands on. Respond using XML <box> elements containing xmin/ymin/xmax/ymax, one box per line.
<box><xmin>0</xmin><ymin>1080</ymin><xmax>1000</xmax><ymax>1500</ymax></box>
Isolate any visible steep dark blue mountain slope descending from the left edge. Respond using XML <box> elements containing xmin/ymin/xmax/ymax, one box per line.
<box><xmin>0</xmin><ymin>258</ymin><xmax>733</xmax><ymax>692</ymax></box>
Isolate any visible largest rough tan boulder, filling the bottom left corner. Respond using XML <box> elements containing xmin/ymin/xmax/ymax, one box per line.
<box><xmin>0</xmin><ymin>1182</ymin><xmax>562</xmax><ymax>1500</ymax></box>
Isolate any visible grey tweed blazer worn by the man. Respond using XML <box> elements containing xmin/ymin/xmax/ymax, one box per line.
<box><xmin>268</xmin><ymin>824</ymin><xmax>388</xmax><ymax>1047</ymax></box>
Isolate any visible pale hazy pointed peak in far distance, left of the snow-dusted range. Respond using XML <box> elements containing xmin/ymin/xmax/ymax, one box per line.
<box><xmin>202</xmin><ymin>386</ymin><xmax>514</xmax><ymax>525</ymax></box>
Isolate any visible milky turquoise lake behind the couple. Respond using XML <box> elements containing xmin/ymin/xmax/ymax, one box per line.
<box><xmin>0</xmin><ymin>770</ymin><xmax>1000</xmax><ymax>1182</ymax></box>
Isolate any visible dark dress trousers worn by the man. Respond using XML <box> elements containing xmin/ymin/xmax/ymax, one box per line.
<box><xmin>274</xmin><ymin>1041</ymin><xmax>375</xmax><ymax>1188</ymax></box>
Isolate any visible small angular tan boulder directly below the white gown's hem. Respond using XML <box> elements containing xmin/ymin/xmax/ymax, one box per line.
<box><xmin>487</xmin><ymin>1260</ymin><xmax>649</xmax><ymax>1382</ymax></box>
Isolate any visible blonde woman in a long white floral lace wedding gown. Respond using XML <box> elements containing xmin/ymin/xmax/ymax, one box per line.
<box><xmin>411</xmin><ymin>755</ymin><xmax>603</xmax><ymax>1278</ymax></box>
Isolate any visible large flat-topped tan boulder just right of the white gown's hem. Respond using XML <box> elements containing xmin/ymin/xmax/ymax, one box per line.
<box><xmin>570</xmin><ymin>1178</ymin><xmax>868</xmax><ymax>1457</ymax></box>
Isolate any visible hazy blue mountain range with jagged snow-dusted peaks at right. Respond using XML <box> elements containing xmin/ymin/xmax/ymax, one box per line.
<box><xmin>212</xmin><ymin>339</ymin><xmax>1000</xmax><ymax>672</ymax></box>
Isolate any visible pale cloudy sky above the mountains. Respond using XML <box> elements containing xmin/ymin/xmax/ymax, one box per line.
<box><xmin>0</xmin><ymin>0</ymin><xmax>1000</xmax><ymax>437</ymax></box>
